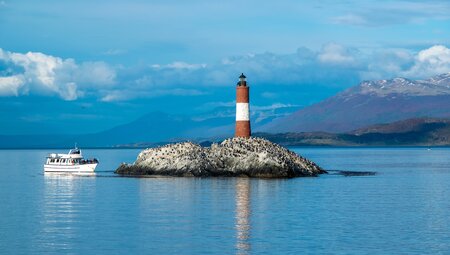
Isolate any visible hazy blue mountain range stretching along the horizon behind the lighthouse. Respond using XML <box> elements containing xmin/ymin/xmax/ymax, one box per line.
<box><xmin>0</xmin><ymin>73</ymin><xmax>450</xmax><ymax>148</ymax></box>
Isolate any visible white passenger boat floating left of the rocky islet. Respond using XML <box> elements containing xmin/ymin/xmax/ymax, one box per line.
<box><xmin>44</xmin><ymin>147</ymin><xmax>98</xmax><ymax>174</ymax></box>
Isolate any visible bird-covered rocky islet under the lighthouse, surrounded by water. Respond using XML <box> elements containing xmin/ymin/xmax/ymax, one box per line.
<box><xmin>115</xmin><ymin>137</ymin><xmax>326</xmax><ymax>178</ymax></box>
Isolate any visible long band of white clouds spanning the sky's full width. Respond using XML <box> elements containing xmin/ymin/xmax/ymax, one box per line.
<box><xmin>0</xmin><ymin>43</ymin><xmax>450</xmax><ymax>102</ymax></box>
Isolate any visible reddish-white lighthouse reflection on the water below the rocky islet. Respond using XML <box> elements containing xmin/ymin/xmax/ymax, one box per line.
<box><xmin>235</xmin><ymin>178</ymin><xmax>250</xmax><ymax>254</ymax></box>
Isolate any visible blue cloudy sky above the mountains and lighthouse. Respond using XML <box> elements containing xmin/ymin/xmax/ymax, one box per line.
<box><xmin>0</xmin><ymin>0</ymin><xmax>450</xmax><ymax>135</ymax></box>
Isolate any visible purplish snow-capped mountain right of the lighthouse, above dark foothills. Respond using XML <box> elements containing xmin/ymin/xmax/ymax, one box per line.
<box><xmin>260</xmin><ymin>73</ymin><xmax>450</xmax><ymax>133</ymax></box>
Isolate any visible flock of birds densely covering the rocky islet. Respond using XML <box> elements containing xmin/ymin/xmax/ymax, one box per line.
<box><xmin>126</xmin><ymin>137</ymin><xmax>321</xmax><ymax>176</ymax></box>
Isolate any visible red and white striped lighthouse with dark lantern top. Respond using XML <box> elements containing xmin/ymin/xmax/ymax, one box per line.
<box><xmin>234</xmin><ymin>73</ymin><xmax>251</xmax><ymax>138</ymax></box>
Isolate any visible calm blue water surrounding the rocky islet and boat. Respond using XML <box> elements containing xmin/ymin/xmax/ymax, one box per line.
<box><xmin>0</xmin><ymin>148</ymin><xmax>450</xmax><ymax>254</ymax></box>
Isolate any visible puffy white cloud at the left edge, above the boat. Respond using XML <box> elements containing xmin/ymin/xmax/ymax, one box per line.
<box><xmin>0</xmin><ymin>49</ymin><xmax>115</xmax><ymax>100</ymax></box>
